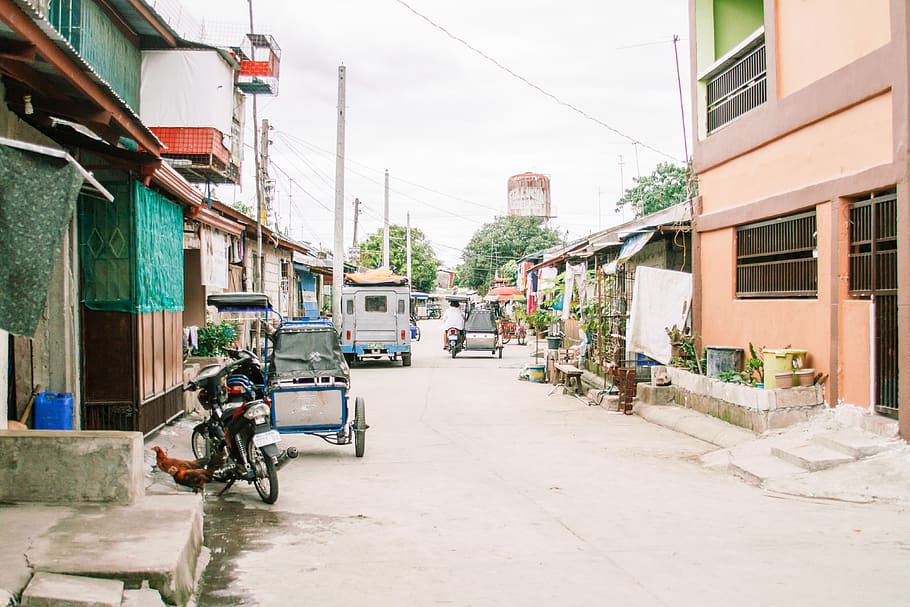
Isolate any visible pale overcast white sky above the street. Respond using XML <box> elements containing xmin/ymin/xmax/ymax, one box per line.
<box><xmin>183</xmin><ymin>0</ymin><xmax>691</xmax><ymax>267</ymax></box>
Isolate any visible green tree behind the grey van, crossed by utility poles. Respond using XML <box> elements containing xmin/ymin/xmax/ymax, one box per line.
<box><xmin>360</xmin><ymin>225</ymin><xmax>439</xmax><ymax>293</ymax></box>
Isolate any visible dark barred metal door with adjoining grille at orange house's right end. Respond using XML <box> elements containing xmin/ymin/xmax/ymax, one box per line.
<box><xmin>850</xmin><ymin>189</ymin><xmax>899</xmax><ymax>418</ymax></box>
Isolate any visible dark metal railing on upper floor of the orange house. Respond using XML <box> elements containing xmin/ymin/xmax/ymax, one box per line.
<box><xmin>703</xmin><ymin>30</ymin><xmax>768</xmax><ymax>134</ymax></box>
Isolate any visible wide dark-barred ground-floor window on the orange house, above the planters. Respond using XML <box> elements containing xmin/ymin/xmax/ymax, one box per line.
<box><xmin>736</xmin><ymin>211</ymin><xmax>818</xmax><ymax>298</ymax></box>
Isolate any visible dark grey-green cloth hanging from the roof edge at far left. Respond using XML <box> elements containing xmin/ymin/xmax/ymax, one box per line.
<box><xmin>0</xmin><ymin>145</ymin><xmax>83</xmax><ymax>337</ymax></box>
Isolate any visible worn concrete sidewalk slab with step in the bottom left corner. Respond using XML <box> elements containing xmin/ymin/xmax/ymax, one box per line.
<box><xmin>0</xmin><ymin>421</ymin><xmax>206</xmax><ymax>607</ymax></box>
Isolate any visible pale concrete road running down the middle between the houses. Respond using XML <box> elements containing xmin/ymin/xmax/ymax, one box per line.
<box><xmin>199</xmin><ymin>321</ymin><xmax>910</xmax><ymax>607</ymax></box>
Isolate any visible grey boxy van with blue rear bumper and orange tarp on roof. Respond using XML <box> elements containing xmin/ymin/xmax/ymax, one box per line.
<box><xmin>341</xmin><ymin>270</ymin><xmax>411</xmax><ymax>367</ymax></box>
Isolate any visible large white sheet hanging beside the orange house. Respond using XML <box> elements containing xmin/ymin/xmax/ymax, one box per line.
<box><xmin>626</xmin><ymin>266</ymin><xmax>692</xmax><ymax>365</ymax></box>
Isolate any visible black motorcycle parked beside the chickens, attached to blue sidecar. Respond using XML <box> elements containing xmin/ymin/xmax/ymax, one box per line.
<box><xmin>184</xmin><ymin>356</ymin><xmax>297</xmax><ymax>504</ymax></box>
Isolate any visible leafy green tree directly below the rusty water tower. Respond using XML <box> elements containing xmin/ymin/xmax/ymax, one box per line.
<box><xmin>455</xmin><ymin>215</ymin><xmax>561</xmax><ymax>292</ymax></box>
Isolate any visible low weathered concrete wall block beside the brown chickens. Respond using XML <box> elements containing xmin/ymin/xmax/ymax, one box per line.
<box><xmin>0</xmin><ymin>430</ymin><xmax>145</xmax><ymax>505</ymax></box>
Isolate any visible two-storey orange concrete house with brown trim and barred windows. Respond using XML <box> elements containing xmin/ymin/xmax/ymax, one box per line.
<box><xmin>689</xmin><ymin>0</ymin><xmax>910</xmax><ymax>439</ymax></box>
